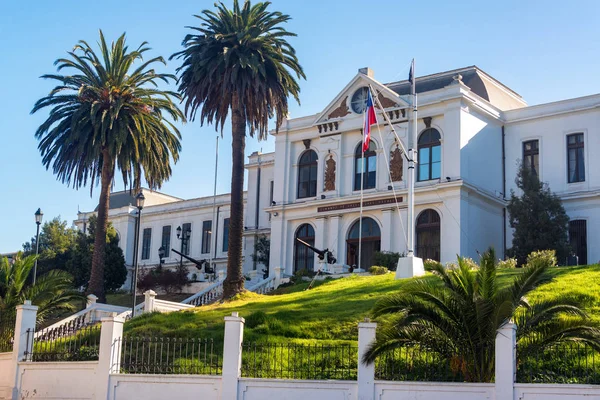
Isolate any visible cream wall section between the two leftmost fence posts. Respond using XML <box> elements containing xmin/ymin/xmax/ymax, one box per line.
<box><xmin>19</xmin><ymin>361</ymin><xmax>98</xmax><ymax>400</ymax></box>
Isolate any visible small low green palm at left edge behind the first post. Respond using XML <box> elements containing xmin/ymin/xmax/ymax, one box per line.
<box><xmin>0</xmin><ymin>253</ymin><xmax>84</xmax><ymax>323</ymax></box>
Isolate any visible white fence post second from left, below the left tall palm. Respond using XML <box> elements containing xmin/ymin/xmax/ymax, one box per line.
<box><xmin>95</xmin><ymin>313</ymin><xmax>125</xmax><ymax>400</ymax></box>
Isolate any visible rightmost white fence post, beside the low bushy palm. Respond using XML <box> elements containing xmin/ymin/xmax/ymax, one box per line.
<box><xmin>496</xmin><ymin>322</ymin><xmax>517</xmax><ymax>400</ymax></box>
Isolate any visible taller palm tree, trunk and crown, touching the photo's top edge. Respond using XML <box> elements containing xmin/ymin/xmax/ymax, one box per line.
<box><xmin>171</xmin><ymin>0</ymin><xmax>305</xmax><ymax>298</ymax></box>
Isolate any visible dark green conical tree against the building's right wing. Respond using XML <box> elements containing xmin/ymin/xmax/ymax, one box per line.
<box><xmin>507</xmin><ymin>165</ymin><xmax>570</xmax><ymax>265</ymax></box>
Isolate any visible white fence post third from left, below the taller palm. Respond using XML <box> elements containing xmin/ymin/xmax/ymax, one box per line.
<box><xmin>221</xmin><ymin>312</ymin><xmax>245</xmax><ymax>400</ymax></box>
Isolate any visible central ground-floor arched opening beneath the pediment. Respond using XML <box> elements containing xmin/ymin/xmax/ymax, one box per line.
<box><xmin>346</xmin><ymin>217</ymin><xmax>381</xmax><ymax>270</ymax></box>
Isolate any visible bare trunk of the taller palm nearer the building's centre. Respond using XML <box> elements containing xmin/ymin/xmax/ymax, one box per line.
<box><xmin>223</xmin><ymin>94</ymin><xmax>246</xmax><ymax>299</ymax></box>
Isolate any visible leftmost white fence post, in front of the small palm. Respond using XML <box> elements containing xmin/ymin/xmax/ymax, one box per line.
<box><xmin>10</xmin><ymin>300</ymin><xmax>38</xmax><ymax>400</ymax></box>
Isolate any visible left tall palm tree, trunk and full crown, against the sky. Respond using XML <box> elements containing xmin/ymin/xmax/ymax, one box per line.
<box><xmin>31</xmin><ymin>31</ymin><xmax>185</xmax><ymax>301</ymax></box>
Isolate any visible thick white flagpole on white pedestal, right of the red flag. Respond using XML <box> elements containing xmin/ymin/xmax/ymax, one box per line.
<box><xmin>407</xmin><ymin>59</ymin><xmax>417</xmax><ymax>257</ymax></box>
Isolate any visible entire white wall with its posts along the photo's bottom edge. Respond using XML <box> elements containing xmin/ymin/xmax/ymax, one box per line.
<box><xmin>0</xmin><ymin>304</ymin><xmax>600</xmax><ymax>400</ymax></box>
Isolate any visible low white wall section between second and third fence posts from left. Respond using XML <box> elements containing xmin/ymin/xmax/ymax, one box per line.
<box><xmin>108</xmin><ymin>375</ymin><xmax>221</xmax><ymax>400</ymax></box>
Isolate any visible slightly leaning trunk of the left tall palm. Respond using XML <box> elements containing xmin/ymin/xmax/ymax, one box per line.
<box><xmin>88</xmin><ymin>150</ymin><xmax>114</xmax><ymax>303</ymax></box>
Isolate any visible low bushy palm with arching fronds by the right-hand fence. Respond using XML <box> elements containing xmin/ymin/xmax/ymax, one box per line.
<box><xmin>363</xmin><ymin>249</ymin><xmax>600</xmax><ymax>382</ymax></box>
